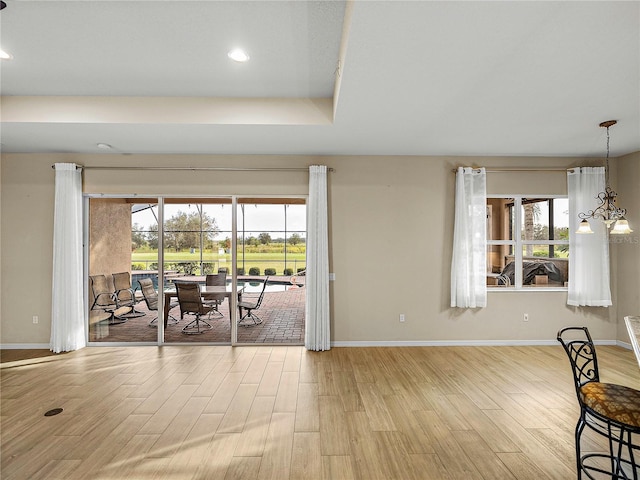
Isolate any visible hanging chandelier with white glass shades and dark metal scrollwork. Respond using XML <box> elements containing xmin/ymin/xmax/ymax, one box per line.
<box><xmin>576</xmin><ymin>120</ymin><xmax>633</xmax><ymax>235</ymax></box>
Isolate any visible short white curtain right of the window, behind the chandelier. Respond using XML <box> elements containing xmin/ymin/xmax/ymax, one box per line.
<box><xmin>567</xmin><ymin>167</ymin><xmax>611</xmax><ymax>307</ymax></box>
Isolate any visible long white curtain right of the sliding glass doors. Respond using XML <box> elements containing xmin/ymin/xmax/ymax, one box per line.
<box><xmin>304</xmin><ymin>165</ymin><xmax>331</xmax><ymax>351</ymax></box>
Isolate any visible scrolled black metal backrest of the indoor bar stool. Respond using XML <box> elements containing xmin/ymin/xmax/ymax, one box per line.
<box><xmin>557</xmin><ymin>327</ymin><xmax>600</xmax><ymax>399</ymax></box>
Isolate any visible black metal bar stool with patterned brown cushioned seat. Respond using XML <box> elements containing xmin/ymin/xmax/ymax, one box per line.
<box><xmin>557</xmin><ymin>327</ymin><xmax>640</xmax><ymax>480</ymax></box>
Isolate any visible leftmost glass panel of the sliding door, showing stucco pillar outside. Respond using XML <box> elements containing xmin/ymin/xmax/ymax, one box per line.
<box><xmin>85</xmin><ymin>197</ymin><xmax>159</xmax><ymax>343</ymax></box>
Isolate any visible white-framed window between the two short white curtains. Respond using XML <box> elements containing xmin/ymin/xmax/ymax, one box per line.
<box><xmin>487</xmin><ymin>196</ymin><xmax>569</xmax><ymax>289</ymax></box>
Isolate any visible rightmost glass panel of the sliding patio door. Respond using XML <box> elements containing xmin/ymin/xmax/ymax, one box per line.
<box><xmin>237</xmin><ymin>197</ymin><xmax>307</xmax><ymax>344</ymax></box>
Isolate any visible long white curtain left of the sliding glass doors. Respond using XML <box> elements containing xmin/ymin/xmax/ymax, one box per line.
<box><xmin>50</xmin><ymin>163</ymin><xmax>86</xmax><ymax>353</ymax></box>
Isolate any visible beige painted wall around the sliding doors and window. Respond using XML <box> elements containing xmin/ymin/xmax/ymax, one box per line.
<box><xmin>0</xmin><ymin>154</ymin><xmax>640</xmax><ymax>344</ymax></box>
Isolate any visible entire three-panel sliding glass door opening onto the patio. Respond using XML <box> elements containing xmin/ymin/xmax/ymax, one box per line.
<box><xmin>85</xmin><ymin>195</ymin><xmax>306</xmax><ymax>345</ymax></box>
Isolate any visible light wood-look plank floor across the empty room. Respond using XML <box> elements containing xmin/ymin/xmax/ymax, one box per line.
<box><xmin>0</xmin><ymin>346</ymin><xmax>640</xmax><ymax>480</ymax></box>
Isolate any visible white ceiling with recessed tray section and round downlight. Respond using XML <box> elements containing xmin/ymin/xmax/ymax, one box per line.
<box><xmin>0</xmin><ymin>0</ymin><xmax>640</xmax><ymax>156</ymax></box>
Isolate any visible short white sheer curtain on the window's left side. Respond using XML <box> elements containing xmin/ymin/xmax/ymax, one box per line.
<box><xmin>451</xmin><ymin>167</ymin><xmax>487</xmax><ymax>308</ymax></box>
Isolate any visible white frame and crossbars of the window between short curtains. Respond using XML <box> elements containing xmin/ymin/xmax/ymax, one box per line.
<box><xmin>486</xmin><ymin>194</ymin><xmax>570</xmax><ymax>292</ymax></box>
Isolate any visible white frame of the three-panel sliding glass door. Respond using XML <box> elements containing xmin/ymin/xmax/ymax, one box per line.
<box><xmin>83</xmin><ymin>193</ymin><xmax>308</xmax><ymax>346</ymax></box>
